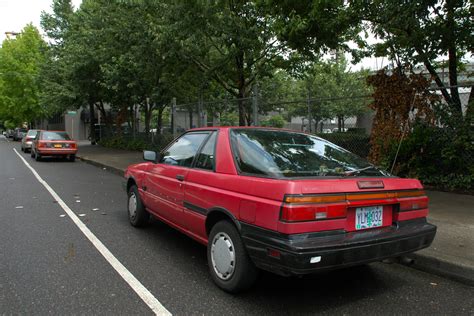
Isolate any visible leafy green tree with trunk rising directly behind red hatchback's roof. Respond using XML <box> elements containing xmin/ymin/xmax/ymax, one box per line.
<box><xmin>168</xmin><ymin>0</ymin><xmax>284</xmax><ymax>125</ymax></box>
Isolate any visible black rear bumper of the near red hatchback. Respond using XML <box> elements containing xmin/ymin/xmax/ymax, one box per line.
<box><xmin>241</xmin><ymin>218</ymin><xmax>436</xmax><ymax>275</ymax></box>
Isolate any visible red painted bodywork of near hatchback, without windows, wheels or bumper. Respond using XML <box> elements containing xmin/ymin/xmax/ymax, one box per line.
<box><xmin>125</xmin><ymin>127</ymin><xmax>435</xmax><ymax>273</ymax></box>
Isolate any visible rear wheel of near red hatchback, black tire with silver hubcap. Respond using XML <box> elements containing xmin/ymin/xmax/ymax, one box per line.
<box><xmin>207</xmin><ymin>220</ymin><xmax>258</xmax><ymax>293</ymax></box>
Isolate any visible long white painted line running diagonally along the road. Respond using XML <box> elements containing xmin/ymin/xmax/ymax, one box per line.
<box><xmin>13</xmin><ymin>148</ymin><xmax>171</xmax><ymax>315</ymax></box>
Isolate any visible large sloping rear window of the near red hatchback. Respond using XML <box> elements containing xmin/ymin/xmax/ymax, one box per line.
<box><xmin>231</xmin><ymin>128</ymin><xmax>389</xmax><ymax>178</ymax></box>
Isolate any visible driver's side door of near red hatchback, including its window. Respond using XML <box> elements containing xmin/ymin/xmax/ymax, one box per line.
<box><xmin>142</xmin><ymin>131</ymin><xmax>209</xmax><ymax>228</ymax></box>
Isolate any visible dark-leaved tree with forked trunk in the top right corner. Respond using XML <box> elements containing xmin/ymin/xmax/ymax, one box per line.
<box><xmin>351</xmin><ymin>0</ymin><xmax>474</xmax><ymax>117</ymax></box>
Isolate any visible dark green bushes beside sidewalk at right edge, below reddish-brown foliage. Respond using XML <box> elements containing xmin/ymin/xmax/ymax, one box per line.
<box><xmin>382</xmin><ymin>122</ymin><xmax>474</xmax><ymax>191</ymax></box>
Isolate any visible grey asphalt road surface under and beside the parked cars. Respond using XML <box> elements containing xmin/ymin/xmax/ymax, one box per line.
<box><xmin>0</xmin><ymin>136</ymin><xmax>474</xmax><ymax>315</ymax></box>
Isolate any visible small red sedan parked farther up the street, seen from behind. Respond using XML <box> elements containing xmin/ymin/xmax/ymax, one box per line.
<box><xmin>31</xmin><ymin>130</ymin><xmax>77</xmax><ymax>161</ymax></box>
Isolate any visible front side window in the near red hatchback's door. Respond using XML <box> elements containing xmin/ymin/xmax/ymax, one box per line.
<box><xmin>160</xmin><ymin>133</ymin><xmax>209</xmax><ymax>167</ymax></box>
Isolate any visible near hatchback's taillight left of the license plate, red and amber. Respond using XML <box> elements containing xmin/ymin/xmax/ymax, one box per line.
<box><xmin>281</xmin><ymin>195</ymin><xmax>347</xmax><ymax>222</ymax></box>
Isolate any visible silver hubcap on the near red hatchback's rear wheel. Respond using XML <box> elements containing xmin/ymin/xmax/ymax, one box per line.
<box><xmin>211</xmin><ymin>232</ymin><xmax>235</xmax><ymax>280</ymax></box>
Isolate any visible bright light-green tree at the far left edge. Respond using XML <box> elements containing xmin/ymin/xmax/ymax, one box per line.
<box><xmin>0</xmin><ymin>24</ymin><xmax>46</xmax><ymax>125</ymax></box>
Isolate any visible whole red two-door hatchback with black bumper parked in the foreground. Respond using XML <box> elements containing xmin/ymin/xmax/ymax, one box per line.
<box><xmin>124</xmin><ymin>127</ymin><xmax>436</xmax><ymax>292</ymax></box>
